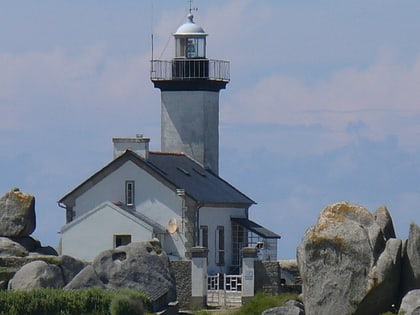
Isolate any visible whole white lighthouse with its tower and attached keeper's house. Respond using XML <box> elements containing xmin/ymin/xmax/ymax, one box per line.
<box><xmin>55</xmin><ymin>12</ymin><xmax>280</xmax><ymax>274</ymax></box>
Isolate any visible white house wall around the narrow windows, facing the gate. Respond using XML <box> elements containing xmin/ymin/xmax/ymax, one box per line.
<box><xmin>199</xmin><ymin>207</ymin><xmax>246</xmax><ymax>274</ymax></box>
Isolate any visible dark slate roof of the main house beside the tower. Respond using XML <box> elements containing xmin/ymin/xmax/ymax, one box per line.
<box><xmin>59</xmin><ymin>150</ymin><xmax>255</xmax><ymax>206</ymax></box>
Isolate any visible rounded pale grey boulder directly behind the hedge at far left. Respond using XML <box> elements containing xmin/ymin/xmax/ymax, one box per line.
<box><xmin>9</xmin><ymin>260</ymin><xmax>64</xmax><ymax>290</ymax></box>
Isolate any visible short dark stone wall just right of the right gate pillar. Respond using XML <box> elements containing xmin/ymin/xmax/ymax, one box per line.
<box><xmin>254</xmin><ymin>260</ymin><xmax>282</xmax><ymax>294</ymax></box>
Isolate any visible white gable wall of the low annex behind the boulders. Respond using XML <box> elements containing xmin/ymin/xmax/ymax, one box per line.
<box><xmin>61</xmin><ymin>203</ymin><xmax>153</xmax><ymax>261</ymax></box>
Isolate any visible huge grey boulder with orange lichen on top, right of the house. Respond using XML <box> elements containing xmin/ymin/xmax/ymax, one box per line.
<box><xmin>297</xmin><ymin>202</ymin><xmax>402</xmax><ymax>315</ymax></box>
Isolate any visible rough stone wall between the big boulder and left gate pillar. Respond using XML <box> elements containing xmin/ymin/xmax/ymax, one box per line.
<box><xmin>171</xmin><ymin>260</ymin><xmax>191</xmax><ymax>307</ymax></box>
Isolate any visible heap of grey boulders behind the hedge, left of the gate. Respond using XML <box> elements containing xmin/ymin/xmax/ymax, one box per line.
<box><xmin>0</xmin><ymin>188</ymin><xmax>176</xmax><ymax>309</ymax></box>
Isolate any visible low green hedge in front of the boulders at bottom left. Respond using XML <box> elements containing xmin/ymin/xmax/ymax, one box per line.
<box><xmin>0</xmin><ymin>288</ymin><xmax>148</xmax><ymax>315</ymax></box>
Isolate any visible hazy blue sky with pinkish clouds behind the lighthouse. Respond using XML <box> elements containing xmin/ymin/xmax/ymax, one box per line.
<box><xmin>0</xmin><ymin>0</ymin><xmax>420</xmax><ymax>259</ymax></box>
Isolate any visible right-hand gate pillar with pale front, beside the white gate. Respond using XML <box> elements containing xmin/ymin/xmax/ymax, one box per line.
<box><xmin>242</xmin><ymin>247</ymin><xmax>258</xmax><ymax>304</ymax></box>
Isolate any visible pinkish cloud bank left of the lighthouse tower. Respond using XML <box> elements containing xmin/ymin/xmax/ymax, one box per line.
<box><xmin>0</xmin><ymin>43</ymin><xmax>158</xmax><ymax>131</ymax></box>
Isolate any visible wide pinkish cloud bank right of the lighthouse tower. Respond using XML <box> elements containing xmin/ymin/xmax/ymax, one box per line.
<box><xmin>221</xmin><ymin>54</ymin><xmax>420</xmax><ymax>154</ymax></box>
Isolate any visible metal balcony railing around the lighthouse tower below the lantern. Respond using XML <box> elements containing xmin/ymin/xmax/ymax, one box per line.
<box><xmin>150</xmin><ymin>59</ymin><xmax>230</xmax><ymax>82</ymax></box>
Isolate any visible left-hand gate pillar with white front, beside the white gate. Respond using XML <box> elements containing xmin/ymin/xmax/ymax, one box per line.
<box><xmin>191</xmin><ymin>247</ymin><xmax>209</xmax><ymax>307</ymax></box>
